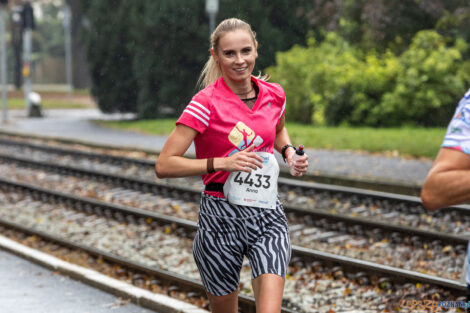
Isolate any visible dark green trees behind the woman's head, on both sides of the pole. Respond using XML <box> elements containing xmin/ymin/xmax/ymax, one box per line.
<box><xmin>86</xmin><ymin>0</ymin><xmax>307</xmax><ymax>118</ymax></box>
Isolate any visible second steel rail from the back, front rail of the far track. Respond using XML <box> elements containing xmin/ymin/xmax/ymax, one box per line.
<box><xmin>0</xmin><ymin>154</ymin><xmax>469</xmax><ymax>245</ymax></box>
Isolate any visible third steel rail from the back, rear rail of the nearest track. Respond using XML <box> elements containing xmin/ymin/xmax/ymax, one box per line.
<box><xmin>0</xmin><ymin>179</ymin><xmax>467</xmax><ymax>295</ymax></box>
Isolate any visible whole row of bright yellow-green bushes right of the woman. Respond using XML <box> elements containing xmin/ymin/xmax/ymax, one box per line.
<box><xmin>268</xmin><ymin>31</ymin><xmax>470</xmax><ymax>126</ymax></box>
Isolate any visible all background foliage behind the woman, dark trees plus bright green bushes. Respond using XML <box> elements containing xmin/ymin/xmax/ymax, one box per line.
<box><xmin>81</xmin><ymin>0</ymin><xmax>470</xmax><ymax>126</ymax></box>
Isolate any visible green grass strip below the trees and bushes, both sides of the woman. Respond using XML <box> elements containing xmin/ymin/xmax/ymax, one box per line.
<box><xmin>100</xmin><ymin>119</ymin><xmax>446</xmax><ymax>158</ymax></box>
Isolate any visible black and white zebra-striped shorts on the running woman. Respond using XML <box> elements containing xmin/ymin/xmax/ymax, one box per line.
<box><xmin>193</xmin><ymin>193</ymin><xmax>291</xmax><ymax>296</ymax></box>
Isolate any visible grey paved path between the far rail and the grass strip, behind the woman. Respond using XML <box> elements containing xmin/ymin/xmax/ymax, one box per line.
<box><xmin>0</xmin><ymin>109</ymin><xmax>432</xmax><ymax>185</ymax></box>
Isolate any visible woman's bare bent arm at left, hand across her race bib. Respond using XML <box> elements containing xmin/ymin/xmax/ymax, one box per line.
<box><xmin>155</xmin><ymin>124</ymin><xmax>263</xmax><ymax>178</ymax></box>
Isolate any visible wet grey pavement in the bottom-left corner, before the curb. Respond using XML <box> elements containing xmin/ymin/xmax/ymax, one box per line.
<box><xmin>0</xmin><ymin>250</ymin><xmax>155</xmax><ymax>313</ymax></box>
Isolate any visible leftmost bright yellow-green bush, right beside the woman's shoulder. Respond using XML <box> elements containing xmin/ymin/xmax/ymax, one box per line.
<box><xmin>267</xmin><ymin>33</ymin><xmax>361</xmax><ymax>124</ymax></box>
